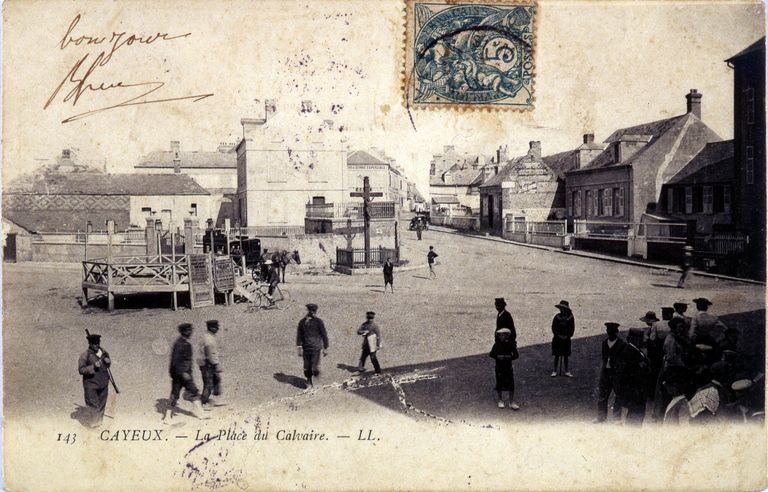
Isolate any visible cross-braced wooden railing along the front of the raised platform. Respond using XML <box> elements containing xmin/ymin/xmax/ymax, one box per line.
<box><xmin>83</xmin><ymin>255</ymin><xmax>189</xmax><ymax>287</ymax></box>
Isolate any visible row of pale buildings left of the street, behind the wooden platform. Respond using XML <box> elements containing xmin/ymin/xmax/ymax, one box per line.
<box><xmin>3</xmin><ymin>101</ymin><xmax>423</xmax><ymax>236</ymax></box>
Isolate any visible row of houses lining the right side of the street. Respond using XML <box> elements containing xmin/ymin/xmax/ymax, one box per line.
<box><xmin>430</xmin><ymin>38</ymin><xmax>766</xmax><ymax>271</ymax></box>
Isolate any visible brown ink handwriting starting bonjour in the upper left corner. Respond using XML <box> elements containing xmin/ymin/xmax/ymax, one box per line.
<box><xmin>43</xmin><ymin>14</ymin><xmax>213</xmax><ymax>123</ymax></box>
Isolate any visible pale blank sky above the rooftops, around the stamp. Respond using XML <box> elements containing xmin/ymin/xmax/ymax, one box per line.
<box><xmin>2</xmin><ymin>0</ymin><xmax>764</xmax><ymax>193</ymax></box>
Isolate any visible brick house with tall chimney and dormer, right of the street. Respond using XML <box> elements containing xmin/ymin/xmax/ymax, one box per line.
<box><xmin>565</xmin><ymin>89</ymin><xmax>722</xmax><ymax>223</ymax></box>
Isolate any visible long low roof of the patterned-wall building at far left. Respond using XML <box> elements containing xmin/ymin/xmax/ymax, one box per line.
<box><xmin>5</xmin><ymin>173</ymin><xmax>209</xmax><ymax>196</ymax></box>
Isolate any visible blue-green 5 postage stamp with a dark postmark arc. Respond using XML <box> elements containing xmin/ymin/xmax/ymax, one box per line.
<box><xmin>403</xmin><ymin>0</ymin><xmax>537</xmax><ymax>110</ymax></box>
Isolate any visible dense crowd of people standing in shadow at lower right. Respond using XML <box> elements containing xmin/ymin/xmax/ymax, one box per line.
<box><xmin>595</xmin><ymin>297</ymin><xmax>763</xmax><ymax>424</ymax></box>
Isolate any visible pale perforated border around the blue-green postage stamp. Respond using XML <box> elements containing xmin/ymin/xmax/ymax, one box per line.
<box><xmin>400</xmin><ymin>0</ymin><xmax>540</xmax><ymax>113</ymax></box>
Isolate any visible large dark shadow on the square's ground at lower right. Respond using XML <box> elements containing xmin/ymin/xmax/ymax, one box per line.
<box><xmin>354</xmin><ymin>310</ymin><xmax>765</xmax><ymax>422</ymax></box>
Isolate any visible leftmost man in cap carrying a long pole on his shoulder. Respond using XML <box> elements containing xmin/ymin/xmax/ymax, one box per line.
<box><xmin>77</xmin><ymin>334</ymin><xmax>112</xmax><ymax>427</ymax></box>
